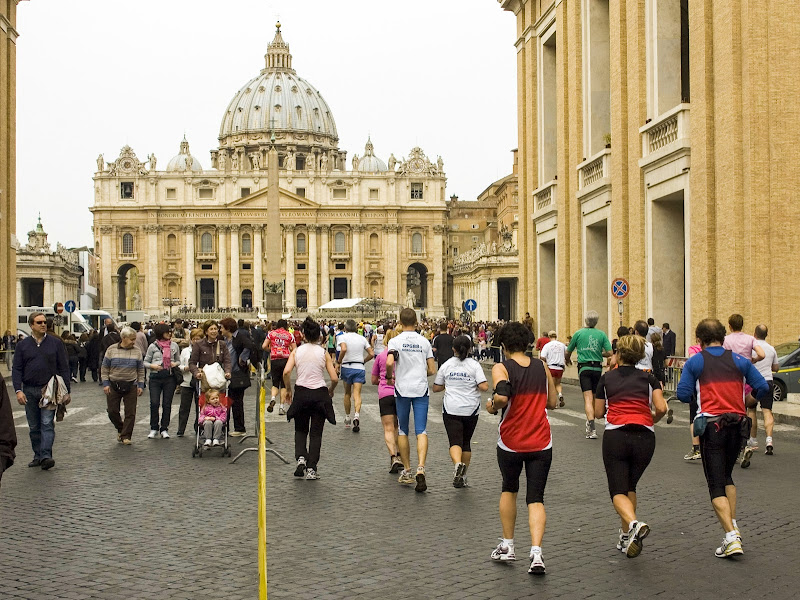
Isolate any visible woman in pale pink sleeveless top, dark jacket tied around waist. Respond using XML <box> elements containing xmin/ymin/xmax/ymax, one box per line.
<box><xmin>284</xmin><ymin>317</ymin><xmax>339</xmax><ymax>480</ymax></box>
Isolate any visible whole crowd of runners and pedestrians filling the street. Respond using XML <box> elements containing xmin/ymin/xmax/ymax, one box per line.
<box><xmin>0</xmin><ymin>309</ymin><xmax>777</xmax><ymax>574</ymax></box>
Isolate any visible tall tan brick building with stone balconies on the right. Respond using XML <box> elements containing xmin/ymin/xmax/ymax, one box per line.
<box><xmin>498</xmin><ymin>0</ymin><xmax>800</xmax><ymax>351</ymax></box>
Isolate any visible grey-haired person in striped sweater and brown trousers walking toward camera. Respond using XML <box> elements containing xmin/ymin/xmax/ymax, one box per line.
<box><xmin>100</xmin><ymin>327</ymin><xmax>144</xmax><ymax>446</ymax></box>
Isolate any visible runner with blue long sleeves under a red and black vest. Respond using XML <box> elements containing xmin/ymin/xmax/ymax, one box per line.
<box><xmin>678</xmin><ymin>319</ymin><xmax>769</xmax><ymax>558</ymax></box>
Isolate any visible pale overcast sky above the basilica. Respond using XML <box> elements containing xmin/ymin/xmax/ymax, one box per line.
<box><xmin>17</xmin><ymin>0</ymin><xmax>517</xmax><ymax>247</ymax></box>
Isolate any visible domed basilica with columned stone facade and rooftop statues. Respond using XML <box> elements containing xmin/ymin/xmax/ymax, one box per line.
<box><xmin>91</xmin><ymin>24</ymin><xmax>447</xmax><ymax>315</ymax></box>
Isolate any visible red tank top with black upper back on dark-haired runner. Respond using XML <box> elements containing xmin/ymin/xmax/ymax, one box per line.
<box><xmin>497</xmin><ymin>359</ymin><xmax>553</xmax><ymax>452</ymax></box>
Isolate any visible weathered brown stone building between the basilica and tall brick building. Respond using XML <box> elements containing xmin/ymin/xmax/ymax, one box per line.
<box><xmin>448</xmin><ymin>150</ymin><xmax>519</xmax><ymax>321</ymax></box>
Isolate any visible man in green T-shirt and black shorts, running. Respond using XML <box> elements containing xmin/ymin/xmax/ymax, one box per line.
<box><xmin>565</xmin><ymin>310</ymin><xmax>611</xmax><ymax>440</ymax></box>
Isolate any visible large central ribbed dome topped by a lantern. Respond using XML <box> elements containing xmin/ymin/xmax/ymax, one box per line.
<box><xmin>219</xmin><ymin>23</ymin><xmax>338</xmax><ymax>149</ymax></box>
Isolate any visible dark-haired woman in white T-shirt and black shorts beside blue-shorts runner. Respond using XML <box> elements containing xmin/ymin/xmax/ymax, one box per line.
<box><xmin>433</xmin><ymin>335</ymin><xmax>489</xmax><ymax>488</ymax></box>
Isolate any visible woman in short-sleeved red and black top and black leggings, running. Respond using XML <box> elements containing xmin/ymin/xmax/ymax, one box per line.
<box><xmin>594</xmin><ymin>335</ymin><xmax>667</xmax><ymax>558</ymax></box>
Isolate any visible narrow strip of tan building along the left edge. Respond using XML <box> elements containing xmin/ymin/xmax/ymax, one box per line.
<box><xmin>0</xmin><ymin>0</ymin><xmax>19</xmax><ymax>331</ymax></box>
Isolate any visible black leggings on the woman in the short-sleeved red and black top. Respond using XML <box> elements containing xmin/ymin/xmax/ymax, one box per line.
<box><xmin>603</xmin><ymin>425</ymin><xmax>656</xmax><ymax>500</ymax></box>
